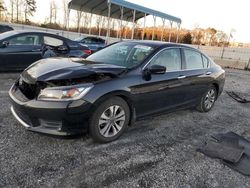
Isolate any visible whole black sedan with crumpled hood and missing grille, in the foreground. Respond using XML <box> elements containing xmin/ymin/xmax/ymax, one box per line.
<box><xmin>9</xmin><ymin>41</ymin><xmax>225</xmax><ymax>142</ymax></box>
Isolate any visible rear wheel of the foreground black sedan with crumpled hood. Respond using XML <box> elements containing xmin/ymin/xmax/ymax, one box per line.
<box><xmin>197</xmin><ymin>86</ymin><xmax>218</xmax><ymax>112</ymax></box>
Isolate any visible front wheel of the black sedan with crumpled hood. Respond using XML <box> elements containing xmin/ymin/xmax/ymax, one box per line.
<box><xmin>89</xmin><ymin>97</ymin><xmax>130</xmax><ymax>143</ymax></box>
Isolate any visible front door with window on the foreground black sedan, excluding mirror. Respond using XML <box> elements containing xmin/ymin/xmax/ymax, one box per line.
<box><xmin>137</xmin><ymin>48</ymin><xmax>186</xmax><ymax>116</ymax></box>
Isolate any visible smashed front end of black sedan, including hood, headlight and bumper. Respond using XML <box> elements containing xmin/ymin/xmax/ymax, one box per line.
<box><xmin>9</xmin><ymin>58</ymin><xmax>125</xmax><ymax>135</ymax></box>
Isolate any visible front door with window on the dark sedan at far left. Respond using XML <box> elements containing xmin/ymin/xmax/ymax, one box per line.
<box><xmin>0</xmin><ymin>34</ymin><xmax>42</xmax><ymax>70</ymax></box>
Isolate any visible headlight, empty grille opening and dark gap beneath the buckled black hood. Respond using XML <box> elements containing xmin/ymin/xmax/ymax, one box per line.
<box><xmin>15</xmin><ymin>73</ymin><xmax>115</xmax><ymax>102</ymax></box>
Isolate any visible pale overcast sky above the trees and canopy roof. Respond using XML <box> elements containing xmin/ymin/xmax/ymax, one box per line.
<box><xmin>29</xmin><ymin>0</ymin><xmax>250</xmax><ymax>43</ymax></box>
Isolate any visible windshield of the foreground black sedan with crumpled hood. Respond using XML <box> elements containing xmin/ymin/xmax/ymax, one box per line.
<box><xmin>87</xmin><ymin>42</ymin><xmax>154</xmax><ymax>68</ymax></box>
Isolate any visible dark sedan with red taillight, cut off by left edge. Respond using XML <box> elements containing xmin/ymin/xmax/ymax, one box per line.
<box><xmin>0</xmin><ymin>31</ymin><xmax>91</xmax><ymax>71</ymax></box>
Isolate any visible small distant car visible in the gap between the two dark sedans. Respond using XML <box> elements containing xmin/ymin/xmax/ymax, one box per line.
<box><xmin>75</xmin><ymin>37</ymin><xmax>106</xmax><ymax>53</ymax></box>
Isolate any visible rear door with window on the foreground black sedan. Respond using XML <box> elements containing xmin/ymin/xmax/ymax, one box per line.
<box><xmin>182</xmin><ymin>48</ymin><xmax>211</xmax><ymax>103</ymax></box>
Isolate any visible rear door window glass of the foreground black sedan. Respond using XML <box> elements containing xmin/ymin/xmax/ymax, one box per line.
<box><xmin>184</xmin><ymin>49</ymin><xmax>204</xmax><ymax>69</ymax></box>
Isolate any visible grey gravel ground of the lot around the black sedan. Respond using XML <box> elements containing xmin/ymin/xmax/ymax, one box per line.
<box><xmin>0</xmin><ymin>69</ymin><xmax>250</xmax><ymax>188</ymax></box>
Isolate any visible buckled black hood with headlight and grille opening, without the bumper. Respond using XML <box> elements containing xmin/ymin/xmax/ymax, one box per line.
<box><xmin>11</xmin><ymin>58</ymin><xmax>126</xmax><ymax>101</ymax></box>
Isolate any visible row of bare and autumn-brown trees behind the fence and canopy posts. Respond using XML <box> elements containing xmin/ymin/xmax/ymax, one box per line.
<box><xmin>0</xmin><ymin>0</ymin><xmax>229</xmax><ymax>46</ymax></box>
